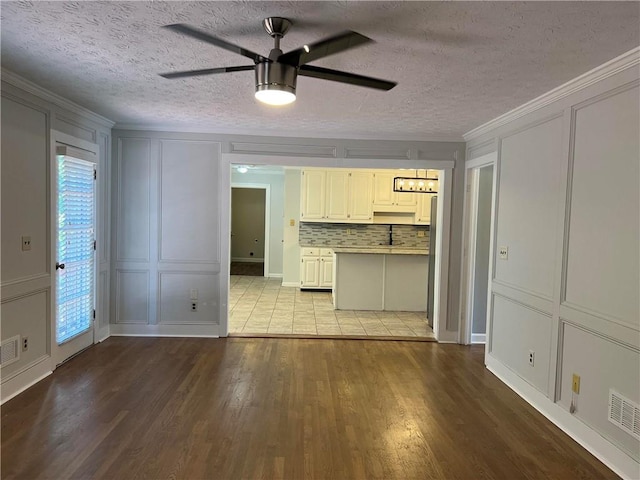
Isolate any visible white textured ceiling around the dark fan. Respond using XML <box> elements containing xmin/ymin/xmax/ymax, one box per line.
<box><xmin>0</xmin><ymin>1</ymin><xmax>640</xmax><ymax>139</ymax></box>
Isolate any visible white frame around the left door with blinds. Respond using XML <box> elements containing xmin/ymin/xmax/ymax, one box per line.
<box><xmin>49</xmin><ymin>130</ymin><xmax>101</xmax><ymax>370</ymax></box>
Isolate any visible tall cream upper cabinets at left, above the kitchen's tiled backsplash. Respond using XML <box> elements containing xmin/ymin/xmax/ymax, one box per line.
<box><xmin>300</xmin><ymin>169</ymin><xmax>373</xmax><ymax>223</ymax></box>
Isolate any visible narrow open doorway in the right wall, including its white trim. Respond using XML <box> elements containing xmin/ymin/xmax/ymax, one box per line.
<box><xmin>460</xmin><ymin>153</ymin><xmax>496</xmax><ymax>344</ymax></box>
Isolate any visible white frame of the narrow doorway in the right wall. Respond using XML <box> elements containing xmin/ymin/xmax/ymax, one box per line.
<box><xmin>458</xmin><ymin>152</ymin><xmax>498</xmax><ymax>345</ymax></box>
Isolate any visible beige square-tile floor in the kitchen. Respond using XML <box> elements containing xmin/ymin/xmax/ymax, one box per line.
<box><xmin>229</xmin><ymin>275</ymin><xmax>434</xmax><ymax>339</ymax></box>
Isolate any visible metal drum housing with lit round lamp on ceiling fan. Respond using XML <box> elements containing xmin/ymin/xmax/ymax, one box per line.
<box><xmin>255</xmin><ymin>62</ymin><xmax>297</xmax><ymax>105</ymax></box>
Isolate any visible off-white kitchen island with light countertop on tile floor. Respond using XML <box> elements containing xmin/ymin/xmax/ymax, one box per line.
<box><xmin>333</xmin><ymin>246</ymin><xmax>429</xmax><ymax>312</ymax></box>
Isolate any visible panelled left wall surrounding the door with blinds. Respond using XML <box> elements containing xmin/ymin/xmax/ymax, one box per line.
<box><xmin>0</xmin><ymin>75</ymin><xmax>112</xmax><ymax>402</ymax></box>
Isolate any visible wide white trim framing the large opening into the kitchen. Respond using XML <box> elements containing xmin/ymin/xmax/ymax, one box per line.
<box><xmin>218</xmin><ymin>153</ymin><xmax>457</xmax><ymax>343</ymax></box>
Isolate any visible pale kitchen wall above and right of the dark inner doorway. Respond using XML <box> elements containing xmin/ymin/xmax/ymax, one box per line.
<box><xmin>231</xmin><ymin>170</ymin><xmax>284</xmax><ymax>277</ymax></box>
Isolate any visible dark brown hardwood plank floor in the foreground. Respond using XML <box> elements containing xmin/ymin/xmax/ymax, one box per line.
<box><xmin>1</xmin><ymin>337</ymin><xmax>617</xmax><ymax>480</ymax></box>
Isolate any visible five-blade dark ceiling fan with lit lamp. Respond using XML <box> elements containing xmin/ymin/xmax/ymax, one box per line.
<box><xmin>160</xmin><ymin>17</ymin><xmax>397</xmax><ymax>105</ymax></box>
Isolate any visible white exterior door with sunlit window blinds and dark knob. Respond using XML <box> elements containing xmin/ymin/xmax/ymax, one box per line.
<box><xmin>53</xmin><ymin>147</ymin><xmax>96</xmax><ymax>364</ymax></box>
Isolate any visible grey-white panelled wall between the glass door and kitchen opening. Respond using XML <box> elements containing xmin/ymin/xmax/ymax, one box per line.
<box><xmin>111</xmin><ymin>133</ymin><xmax>227</xmax><ymax>336</ymax></box>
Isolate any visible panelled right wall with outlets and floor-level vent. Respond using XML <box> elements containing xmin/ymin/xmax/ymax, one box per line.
<box><xmin>467</xmin><ymin>51</ymin><xmax>640</xmax><ymax>478</ymax></box>
